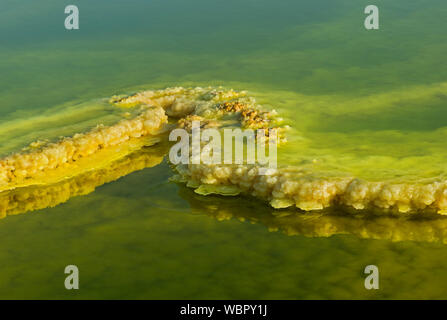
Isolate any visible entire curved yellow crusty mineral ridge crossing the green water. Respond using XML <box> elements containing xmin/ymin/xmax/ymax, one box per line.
<box><xmin>0</xmin><ymin>87</ymin><xmax>447</xmax><ymax>218</ymax></box>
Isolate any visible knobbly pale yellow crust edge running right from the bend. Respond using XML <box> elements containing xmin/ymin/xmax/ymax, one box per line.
<box><xmin>176</xmin><ymin>164</ymin><xmax>447</xmax><ymax>214</ymax></box>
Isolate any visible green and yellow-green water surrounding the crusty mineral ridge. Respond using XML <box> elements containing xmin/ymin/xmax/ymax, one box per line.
<box><xmin>0</xmin><ymin>0</ymin><xmax>447</xmax><ymax>299</ymax></box>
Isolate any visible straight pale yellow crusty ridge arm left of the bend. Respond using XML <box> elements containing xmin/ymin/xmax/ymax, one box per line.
<box><xmin>0</xmin><ymin>107</ymin><xmax>167</xmax><ymax>191</ymax></box>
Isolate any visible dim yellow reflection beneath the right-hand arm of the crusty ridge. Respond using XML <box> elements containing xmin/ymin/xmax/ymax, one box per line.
<box><xmin>179</xmin><ymin>187</ymin><xmax>447</xmax><ymax>243</ymax></box>
